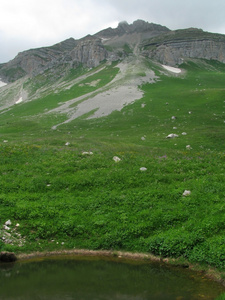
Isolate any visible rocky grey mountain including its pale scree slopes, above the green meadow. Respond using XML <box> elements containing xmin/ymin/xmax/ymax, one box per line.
<box><xmin>0</xmin><ymin>20</ymin><xmax>225</xmax><ymax>117</ymax></box>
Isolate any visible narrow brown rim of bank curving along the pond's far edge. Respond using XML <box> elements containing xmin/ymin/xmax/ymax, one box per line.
<box><xmin>16</xmin><ymin>249</ymin><xmax>225</xmax><ymax>286</ymax></box>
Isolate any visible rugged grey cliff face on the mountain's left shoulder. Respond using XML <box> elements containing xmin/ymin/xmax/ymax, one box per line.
<box><xmin>0</xmin><ymin>36</ymin><xmax>108</xmax><ymax>82</ymax></box>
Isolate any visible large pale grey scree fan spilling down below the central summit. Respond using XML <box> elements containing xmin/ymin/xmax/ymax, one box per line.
<box><xmin>48</xmin><ymin>58</ymin><xmax>157</xmax><ymax>129</ymax></box>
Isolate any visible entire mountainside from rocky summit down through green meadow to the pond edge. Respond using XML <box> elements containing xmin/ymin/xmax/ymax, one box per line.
<box><xmin>0</xmin><ymin>20</ymin><xmax>225</xmax><ymax>279</ymax></box>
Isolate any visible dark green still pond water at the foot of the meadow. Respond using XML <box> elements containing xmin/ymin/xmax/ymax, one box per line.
<box><xmin>0</xmin><ymin>257</ymin><xmax>224</xmax><ymax>300</ymax></box>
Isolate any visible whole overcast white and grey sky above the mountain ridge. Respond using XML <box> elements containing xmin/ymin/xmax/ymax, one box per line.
<box><xmin>0</xmin><ymin>0</ymin><xmax>225</xmax><ymax>63</ymax></box>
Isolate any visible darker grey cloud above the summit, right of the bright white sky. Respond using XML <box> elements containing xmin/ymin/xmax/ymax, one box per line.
<box><xmin>105</xmin><ymin>0</ymin><xmax>225</xmax><ymax>34</ymax></box>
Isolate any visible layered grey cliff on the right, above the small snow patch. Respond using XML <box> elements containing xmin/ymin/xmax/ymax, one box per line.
<box><xmin>143</xmin><ymin>29</ymin><xmax>225</xmax><ymax>66</ymax></box>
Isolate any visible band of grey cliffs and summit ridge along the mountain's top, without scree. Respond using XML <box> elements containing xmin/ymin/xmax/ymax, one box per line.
<box><xmin>0</xmin><ymin>20</ymin><xmax>225</xmax><ymax>82</ymax></box>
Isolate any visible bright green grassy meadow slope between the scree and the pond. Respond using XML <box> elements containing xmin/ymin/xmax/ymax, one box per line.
<box><xmin>0</xmin><ymin>61</ymin><xmax>225</xmax><ymax>270</ymax></box>
